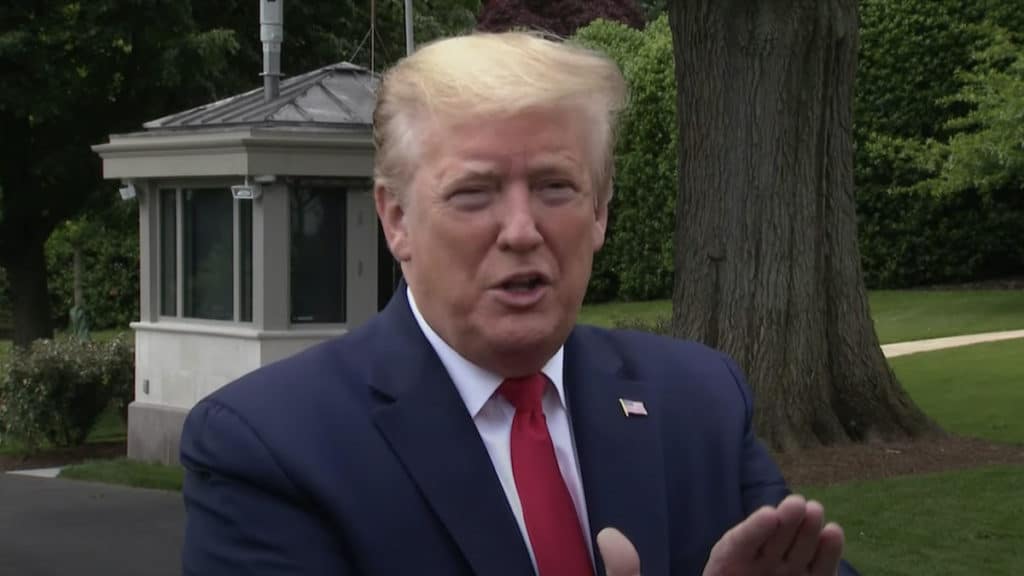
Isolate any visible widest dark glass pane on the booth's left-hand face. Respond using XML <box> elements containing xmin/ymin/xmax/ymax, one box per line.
<box><xmin>181</xmin><ymin>189</ymin><xmax>234</xmax><ymax>320</ymax></box>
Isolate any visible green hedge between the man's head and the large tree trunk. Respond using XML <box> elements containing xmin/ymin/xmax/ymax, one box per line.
<box><xmin>575</xmin><ymin>16</ymin><xmax>678</xmax><ymax>301</ymax></box>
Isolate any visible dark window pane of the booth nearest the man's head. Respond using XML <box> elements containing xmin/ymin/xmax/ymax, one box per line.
<box><xmin>291</xmin><ymin>188</ymin><xmax>345</xmax><ymax>324</ymax></box>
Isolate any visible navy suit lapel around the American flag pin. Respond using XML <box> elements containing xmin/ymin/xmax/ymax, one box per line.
<box><xmin>565</xmin><ymin>328</ymin><xmax>669</xmax><ymax>576</ymax></box>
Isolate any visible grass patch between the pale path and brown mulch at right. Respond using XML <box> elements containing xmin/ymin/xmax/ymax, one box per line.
<box><xmin>889</xmin><ymin>339</ymin><xmax>1024</xmax><ymax>440</ymax></box>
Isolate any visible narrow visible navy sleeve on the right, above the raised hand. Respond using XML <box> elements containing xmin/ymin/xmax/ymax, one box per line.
<box><xmin>725</xmin><ymin>358</ymin><xmax>859</xmax><ymax>576</ymax></box>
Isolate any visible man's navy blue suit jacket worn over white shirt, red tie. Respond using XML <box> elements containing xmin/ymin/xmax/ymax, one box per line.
<box><xmin>181</xmin><ymin>290</ymin><xmax>856</xmax><ymax>576</ymax></box>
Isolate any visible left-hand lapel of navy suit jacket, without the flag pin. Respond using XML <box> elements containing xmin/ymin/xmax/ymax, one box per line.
<box><xmin>371</xmin><ymin>285</ymin><xmax>534</xmax><ymax>575</ymax></box>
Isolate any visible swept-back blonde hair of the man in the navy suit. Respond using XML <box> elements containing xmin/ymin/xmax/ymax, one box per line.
<box><xmin>374</xmin><ymin>32</ymin><xmax>627</xmax><ymax>202</ymax></box>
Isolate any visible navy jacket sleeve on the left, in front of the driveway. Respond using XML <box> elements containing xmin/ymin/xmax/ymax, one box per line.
<box><xmin>181</xmin><ymin>400</ymin><xmax>352</xmax><ymax>576</ymax></box>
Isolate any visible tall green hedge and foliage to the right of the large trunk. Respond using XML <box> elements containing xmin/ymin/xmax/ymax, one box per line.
<box><xmin>856</xmin><ymin>5</ymin><xmax>1024</xmax><ymax>288</ymax></box>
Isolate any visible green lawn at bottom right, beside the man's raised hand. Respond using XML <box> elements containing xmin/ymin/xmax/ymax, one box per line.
<box><xmin>803</xmin><ymin>466</ymin><xmax>1024</xmax><ymax>576</ymax></box>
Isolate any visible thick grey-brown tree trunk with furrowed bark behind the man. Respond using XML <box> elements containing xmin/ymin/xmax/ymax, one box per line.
<box><xmin>670</xmin><ymin>0</ymin><xmax>937</xmax><ymax>451</ymax></box>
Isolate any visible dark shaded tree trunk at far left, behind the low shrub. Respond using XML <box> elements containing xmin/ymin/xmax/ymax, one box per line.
<box><xmin>7</xmin><ymin>238</ymin><xmax>53</xmax><ymax>347</ymax></box>
